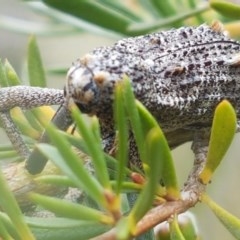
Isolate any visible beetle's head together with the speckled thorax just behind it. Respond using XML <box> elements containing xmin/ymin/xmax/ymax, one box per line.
<box><xmin>65</xmin><ymin>46</ymin><xmax>150</xmax><ymax>119</ymax></box>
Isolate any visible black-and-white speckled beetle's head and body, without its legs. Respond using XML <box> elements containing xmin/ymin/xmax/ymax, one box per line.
<box><xmin>65</xmin><ymin>24</ymin><xmax>240</xmax><ymax>139</ymax></box>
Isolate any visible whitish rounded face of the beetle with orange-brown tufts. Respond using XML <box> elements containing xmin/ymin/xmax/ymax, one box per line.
<box><xmin>65</xmin><ymin>55</ymin><xmax>110</xmax><ymax>113</ymax></box>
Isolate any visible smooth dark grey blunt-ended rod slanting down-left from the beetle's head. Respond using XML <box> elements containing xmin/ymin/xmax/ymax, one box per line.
<box><xmin>25</xmin><ymin>104</ymin><xmax>73</xmax><ymax>174</ymax></box>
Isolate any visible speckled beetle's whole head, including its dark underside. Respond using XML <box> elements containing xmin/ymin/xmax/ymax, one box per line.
<box><xmin>65</xmin><ymin>54</ymin><xmax>118</xmax><ymax>115</ymax></box>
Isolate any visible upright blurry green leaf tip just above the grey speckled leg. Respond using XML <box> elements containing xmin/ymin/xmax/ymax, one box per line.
<box><xmin>28</xmin><ymin>35</ymin><xmax>46</xmax><ymax>87</ymax></box>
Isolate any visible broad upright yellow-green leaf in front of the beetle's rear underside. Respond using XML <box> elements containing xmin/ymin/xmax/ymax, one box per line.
<box><xmin>199</xmin><ymin>100</ymin><xmax>237</xmax><ymax>184</ymax></box>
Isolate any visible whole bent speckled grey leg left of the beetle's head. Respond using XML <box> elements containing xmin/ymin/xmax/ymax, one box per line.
<box><xmin>0</xmin><ymin>86</ymin><xmax>64</xmax><ymax>158</ymax></box>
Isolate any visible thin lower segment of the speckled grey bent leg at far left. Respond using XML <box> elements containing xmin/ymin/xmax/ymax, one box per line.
<box><xmin>0</xmin><ymin>111</ymin><xmax>30</xmax><ymax>159</ymax></box>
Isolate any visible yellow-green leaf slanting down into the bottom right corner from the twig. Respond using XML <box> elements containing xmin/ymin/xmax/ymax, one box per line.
<box><xmin>201</xmin><ymin>194</ymin><xmax>240</xmax><ymax>239</ymax></box>
